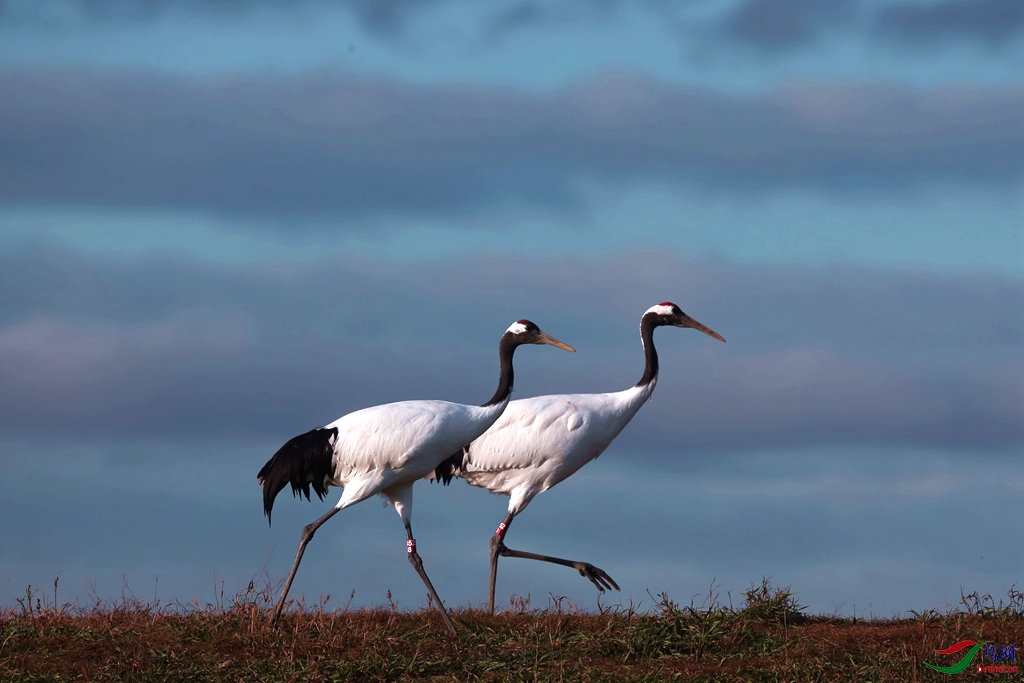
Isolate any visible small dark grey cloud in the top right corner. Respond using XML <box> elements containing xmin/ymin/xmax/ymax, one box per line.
<box><xmin>874</xmin><ymin>0</ymin><xmax>1024</xmax><ymax>47</ymax></box>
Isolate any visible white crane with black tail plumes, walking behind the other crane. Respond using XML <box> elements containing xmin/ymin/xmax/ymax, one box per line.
<box><xmin>258</xmin><ymin>321</ymin><xmax>575</xmax><ymax>635</ymax></box>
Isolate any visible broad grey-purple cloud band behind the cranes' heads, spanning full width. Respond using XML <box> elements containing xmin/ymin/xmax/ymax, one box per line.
<box><xmin>0</xmin><ymin>242</ymin><xmax>1024</xmax><ymax>461</ymax></box>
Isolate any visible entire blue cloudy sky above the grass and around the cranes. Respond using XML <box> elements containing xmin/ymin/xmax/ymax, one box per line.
<box><xmin>0</xmin><ymin>0</ymin><xmax>1024</xmax><ymax>617</ymax></box>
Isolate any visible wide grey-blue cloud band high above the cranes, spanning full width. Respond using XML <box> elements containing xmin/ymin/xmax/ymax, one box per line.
<box><xmin>0</xmin><ymin>65</ymin><xmax>1024</xmax><ymax>218</ymax></box>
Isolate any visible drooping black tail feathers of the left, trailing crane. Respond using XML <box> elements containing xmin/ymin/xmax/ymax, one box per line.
<box><xmin>256</xmin><ymin>427</ymin><xmax>338</xmax><ymax>523</ymax></box>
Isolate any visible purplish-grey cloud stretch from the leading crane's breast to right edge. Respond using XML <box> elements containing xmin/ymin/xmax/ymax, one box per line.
<box><xmin>637</xmin><ymin>346</ymin><xmax>1024</xmax><ymax>462</ymax></box>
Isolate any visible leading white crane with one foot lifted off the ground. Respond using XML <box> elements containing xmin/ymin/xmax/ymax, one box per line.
<box><xmin>428</xmin><ymin>301</ymin><xmax>725</xmax><ymax>614</ymax></box>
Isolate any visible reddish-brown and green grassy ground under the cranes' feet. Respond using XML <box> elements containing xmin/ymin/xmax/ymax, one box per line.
<box><xmin>0</xmin><ymin>580</ymin><xmax>1024</xmax><ymax>682</ymax></box>
